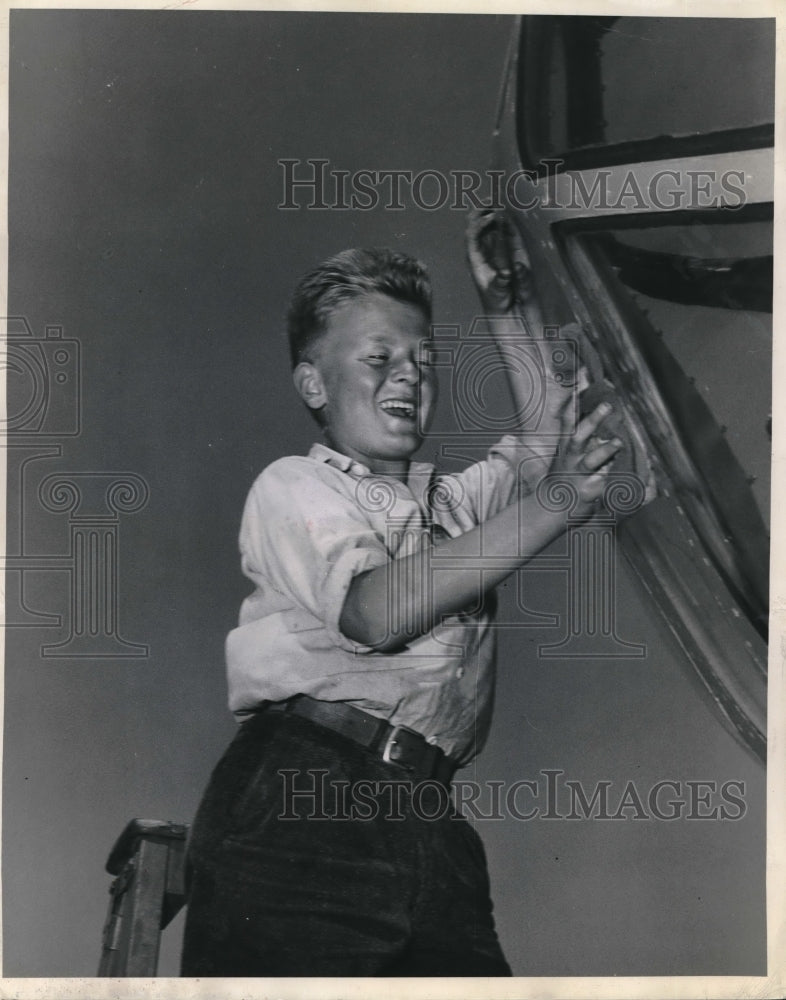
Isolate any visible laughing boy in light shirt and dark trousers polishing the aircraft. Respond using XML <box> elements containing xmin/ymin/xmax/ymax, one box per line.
<box><xmin>182</xmin><ymin>214</ymin><xmax>621</xmax><ymax>976</ymax></box>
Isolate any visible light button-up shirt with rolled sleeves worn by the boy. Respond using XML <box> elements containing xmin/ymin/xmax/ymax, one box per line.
<box><xmin>226</xmin><ymin>435</ymin><xmax>544</xmax><ymax>763</ymax></box>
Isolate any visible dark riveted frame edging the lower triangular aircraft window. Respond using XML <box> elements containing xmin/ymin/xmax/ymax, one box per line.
<box><xmin>552</xmin><ymin>205</ymin><xmax>772</xmax><ymax>638</ymax></box>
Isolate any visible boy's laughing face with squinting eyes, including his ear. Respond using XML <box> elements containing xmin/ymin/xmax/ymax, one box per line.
<box><xmin>295</xmin><ymin>292</ymin><xmax>437</xmax><ymax>478</ymax></box>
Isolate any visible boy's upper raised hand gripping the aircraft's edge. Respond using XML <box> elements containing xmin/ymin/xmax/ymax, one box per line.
<box><xmin>466</xmin><ymin>208</ymin><xmax>534</xmax><ymax>313</ymax></box>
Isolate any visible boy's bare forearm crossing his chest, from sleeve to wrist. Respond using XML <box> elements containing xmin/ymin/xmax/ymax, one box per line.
<box><xmin>340</xmin><ymin>496</ymin><xmax>565</xmax><ymax>652</ymax></box>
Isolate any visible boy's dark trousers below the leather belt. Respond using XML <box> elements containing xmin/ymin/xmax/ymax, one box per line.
<box><xmin>182</xmin><ymin>712</ymin><xmax>511</xmax><ymax>976</ymax></box>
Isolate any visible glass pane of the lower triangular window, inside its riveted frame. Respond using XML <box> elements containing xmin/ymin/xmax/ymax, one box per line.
<box><xmin>597</xmin><ymin>221</ymin><xmax>773</xmax><ymax>523</ymax></box>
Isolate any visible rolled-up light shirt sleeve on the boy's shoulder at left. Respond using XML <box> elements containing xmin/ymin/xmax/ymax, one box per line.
<box><xmin>240</xmin><ymin>458</ymin><xmax>389</xmax><ymax>653</ymax></box>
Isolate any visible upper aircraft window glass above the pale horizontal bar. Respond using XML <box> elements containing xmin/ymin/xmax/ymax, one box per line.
<box><xmin>519</xmin><ymin>17</ymin><xmax>775</xmax><ymax>165</ymax></box>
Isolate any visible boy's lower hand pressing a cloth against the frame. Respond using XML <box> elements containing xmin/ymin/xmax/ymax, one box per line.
<box><xmin>549</xmin><ymin>402</ymin><xmax>622</xmax><ymax>516</ymax></box>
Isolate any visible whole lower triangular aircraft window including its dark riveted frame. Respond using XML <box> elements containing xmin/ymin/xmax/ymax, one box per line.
<box><xmin>563</xmin><ymin>212</ymin><xmax>772</xmax><ymax>631</ymax></box>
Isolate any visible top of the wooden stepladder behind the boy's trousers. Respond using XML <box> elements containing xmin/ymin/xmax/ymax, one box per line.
<box><xmin>98</xmin><ymin>819</ymin><xmax>188</xmax><ymax>977</ymax></box>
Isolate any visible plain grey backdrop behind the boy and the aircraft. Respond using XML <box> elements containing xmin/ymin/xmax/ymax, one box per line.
<box><xmin>3</xmin><ymin>11</ymin><xmax>765</xmax><ymax>976</ymax></box>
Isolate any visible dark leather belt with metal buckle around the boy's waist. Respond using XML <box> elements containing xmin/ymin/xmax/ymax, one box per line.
<box><xmin>261</xmin><ymin>694</ymin><xmax>458</xmax><ymax>785</ymax></box>
